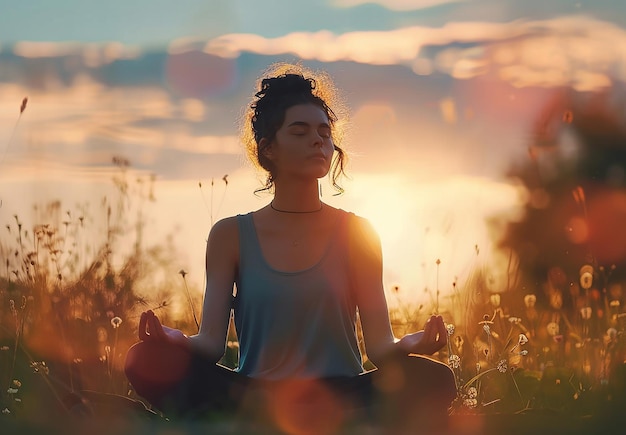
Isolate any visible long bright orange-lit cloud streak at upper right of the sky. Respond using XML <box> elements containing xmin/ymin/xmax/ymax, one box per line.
<box><xmin>200</xmin><ymin>15</ymin><xmax>626</xmax><ymax>91</ymax></box>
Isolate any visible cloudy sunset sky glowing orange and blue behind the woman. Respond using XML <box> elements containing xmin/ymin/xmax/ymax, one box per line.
<box><xmin>0</xmin><ymin>0</ymin><xmax>626</xmax><ymax>312</ymax></box>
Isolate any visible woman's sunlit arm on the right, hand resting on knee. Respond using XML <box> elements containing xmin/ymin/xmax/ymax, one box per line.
<box><xmin>349</xmin><ymin>217</ymin><xmax>447</xmax><ymax>367</ymax></box>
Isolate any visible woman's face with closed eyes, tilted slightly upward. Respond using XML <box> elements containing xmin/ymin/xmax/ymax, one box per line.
<box><xmin>266</xmin><ymin>104</ymin><xmax>335</xmax><ymax>180</ymax></box>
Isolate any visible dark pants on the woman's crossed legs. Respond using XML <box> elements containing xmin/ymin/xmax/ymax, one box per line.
<box><xmin>125</xmin><ymin>341</ymin><xmax>456</xmax><ymax>425</ymax></box>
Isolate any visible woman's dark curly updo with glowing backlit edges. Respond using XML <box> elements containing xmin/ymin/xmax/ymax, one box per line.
<box><xmin>242</xmin><ymin>64</ymin><xmax>347</xmax><ymax>194</ymax></box>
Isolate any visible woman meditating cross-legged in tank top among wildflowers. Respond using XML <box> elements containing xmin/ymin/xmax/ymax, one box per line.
<box><xmin>126</xmin><ymin>66</ymin><xmax>456</xmax><ymax>430</ymax></box>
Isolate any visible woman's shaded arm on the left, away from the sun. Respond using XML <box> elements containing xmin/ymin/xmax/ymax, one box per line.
<box><xmin>139</xmin><ymin>217</ymin><xmax>239</xmax><ymax>362</ymax></box>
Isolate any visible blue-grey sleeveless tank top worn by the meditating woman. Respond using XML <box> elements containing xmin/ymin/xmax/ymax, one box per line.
<box><xmin>234</xmin><ymin>213</ymin><xmax>363</xmax><ymax>380</ymax></box>
